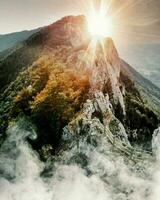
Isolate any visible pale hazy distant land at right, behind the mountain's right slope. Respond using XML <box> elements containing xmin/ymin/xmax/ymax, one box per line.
<box><xmin>119</xmin><ymin>44</ymin><xmax>160</xmax><ymax>87</ymax></box>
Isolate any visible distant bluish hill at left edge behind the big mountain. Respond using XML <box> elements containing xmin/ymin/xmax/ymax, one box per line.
<box><xmin>0</xmin><ymin>29</ymin><xmax>39</xmax><ymax>52</ymax></box>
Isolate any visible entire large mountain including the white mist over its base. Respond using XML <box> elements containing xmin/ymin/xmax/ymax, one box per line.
<box><xmin>0</xmin><ymin>16</ymin><xmax>160</xmax><ymax>200</ymax></box>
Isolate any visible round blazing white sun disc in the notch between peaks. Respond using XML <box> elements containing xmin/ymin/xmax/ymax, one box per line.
<box><xmin>87</xmin><ymin>7</ymin><xmax>113</xmax><ymax>38</ymax></box>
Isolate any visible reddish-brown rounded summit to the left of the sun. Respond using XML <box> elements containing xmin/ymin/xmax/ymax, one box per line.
<box><xmin>28</xmin><ymin>16</ymin><xmax>88</xmax><ymax>48</ymax></box>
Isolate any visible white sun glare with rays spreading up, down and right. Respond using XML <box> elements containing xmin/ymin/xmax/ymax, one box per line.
<box><xmin>79</xmin><ymin>0</ymin><xmax>160</xmax><ymax>67</ymax></box>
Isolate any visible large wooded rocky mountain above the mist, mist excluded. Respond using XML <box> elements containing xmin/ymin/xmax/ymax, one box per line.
<box><xmin>0</xmin><ymin>16</ymin><xmax>160</xmax><ymax>155</ymax></box>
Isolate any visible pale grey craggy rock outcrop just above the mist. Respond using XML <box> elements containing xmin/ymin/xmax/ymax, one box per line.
<box><xmin>62</xmin><ymin>91</ymin><xmax>131</xmax><ymax>147</ymax></box>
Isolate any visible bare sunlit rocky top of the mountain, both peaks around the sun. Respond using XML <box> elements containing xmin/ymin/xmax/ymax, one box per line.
<box><xmin>29</xmin><ymin>16</ymin><xmax>125</xmax><ymax>113</ymax></box>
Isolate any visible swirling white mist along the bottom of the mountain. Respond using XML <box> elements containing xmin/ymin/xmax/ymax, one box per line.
<box><xmin>0</xmin><ymin>118</ymin><xmax>160</xmax><ymax>200</ymax></box>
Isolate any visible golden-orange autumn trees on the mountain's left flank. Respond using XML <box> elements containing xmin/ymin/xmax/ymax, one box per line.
<box><xmin>14</xmin><ymin>56</ymin><xmax>89</xmax><ymax>148</ymax></box>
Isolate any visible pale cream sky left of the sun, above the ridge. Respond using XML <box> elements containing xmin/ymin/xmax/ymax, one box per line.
<box><xmin>0</xmin><ymin>0</ymin><xmax>83</xmax><ymax>34</ymax></box>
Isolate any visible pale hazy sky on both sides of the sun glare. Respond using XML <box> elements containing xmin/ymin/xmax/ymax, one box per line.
<box><xmin>0</xmin><ymin>0</ymin><xmax>160</xmax><ymax>42</ymax></box>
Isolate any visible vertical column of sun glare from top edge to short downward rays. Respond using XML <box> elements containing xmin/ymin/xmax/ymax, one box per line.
<box><xmin>80</xmin><ymin>0</ymin><xmax>114</xmax><ymax>64</ymax></box>
